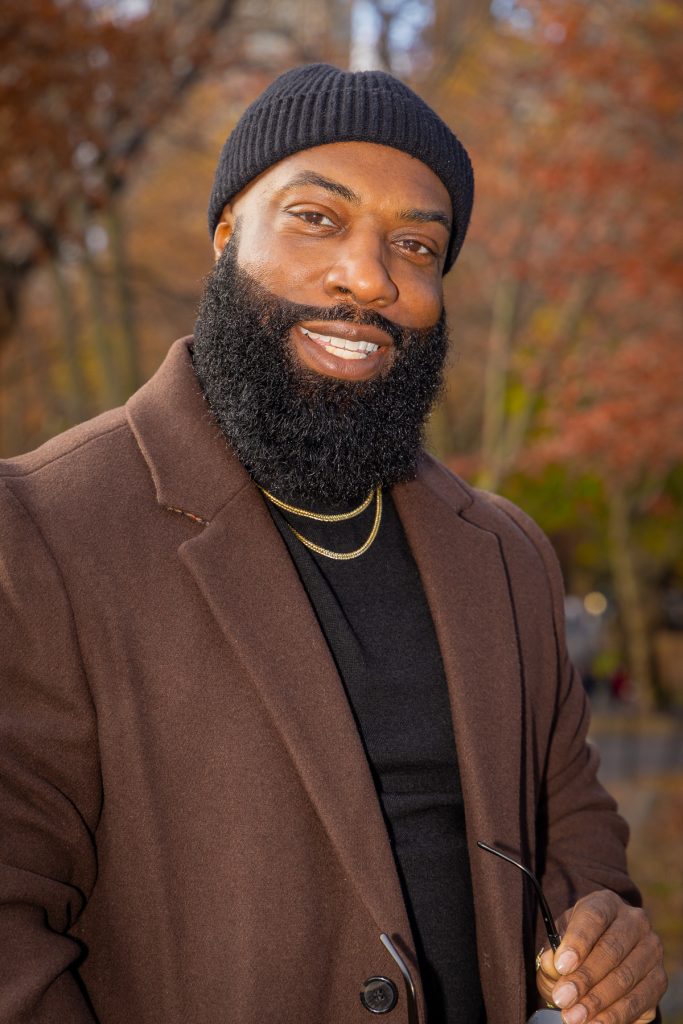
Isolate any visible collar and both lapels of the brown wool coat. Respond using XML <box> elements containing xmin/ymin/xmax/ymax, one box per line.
<box><xmin>127</xmin><ymin>339</ymin><xmax>524</xmax><ymax>1020</ymax></box>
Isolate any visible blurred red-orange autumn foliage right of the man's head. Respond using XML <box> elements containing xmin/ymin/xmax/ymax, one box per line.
<box><xmin>440</xmin><ymin>2</ymin><xmax>683</xmax><ymax>483</ymax></box>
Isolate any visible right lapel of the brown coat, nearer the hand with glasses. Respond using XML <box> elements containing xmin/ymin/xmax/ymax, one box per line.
<box><xmin>393</xmin><ymin>459</ymin><xmax>525</xmax><ymax>1021</ymax></box>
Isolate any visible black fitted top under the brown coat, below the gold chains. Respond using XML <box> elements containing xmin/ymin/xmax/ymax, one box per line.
<box><xmin>267</xmin><ymin>492</ymin><xmax>485</xmax><ymax>1024</ymax></box>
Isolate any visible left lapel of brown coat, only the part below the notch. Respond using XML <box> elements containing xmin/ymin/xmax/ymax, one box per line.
<box><xmin>180</xmin><ymin>484</ymin><xmax>410</xmax><ymax>937</ymax></box>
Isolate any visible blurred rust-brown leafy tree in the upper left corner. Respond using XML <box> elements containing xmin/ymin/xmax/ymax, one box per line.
<box><xmin>0</xmin><ymin>0</ymin><xmax>240</xmax><ymax>419</ymax></box>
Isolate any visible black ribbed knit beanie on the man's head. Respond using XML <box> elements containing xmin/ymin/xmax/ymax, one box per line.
<box><xmin>209</xmin><ymin>63</ymin><xmax>474</xmax><ymax>273</ymax></box>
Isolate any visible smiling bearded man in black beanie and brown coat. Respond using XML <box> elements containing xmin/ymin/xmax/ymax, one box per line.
<box><xmin>0</xmin><ymin>65</ymin><xmax>666</xmax><ymax>1024</ymax></box>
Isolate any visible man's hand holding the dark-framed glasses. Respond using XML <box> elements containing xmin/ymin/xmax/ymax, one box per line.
<box><xmin>537</xmin><ymin>890</ymin><xmax>667</xmax><ymax>1024</ymax></box>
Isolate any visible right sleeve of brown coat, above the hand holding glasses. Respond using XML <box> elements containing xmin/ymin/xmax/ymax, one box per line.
<box><xmin>485</xmin><ymin>498</ymin><xmax>641</xmax><ymax>944</ymax></box>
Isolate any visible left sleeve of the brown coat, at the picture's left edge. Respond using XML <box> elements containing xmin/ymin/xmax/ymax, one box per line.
<box><xmin>0</xmin><ymin>480</ymin><xmax>101</xmax><ymax>1024</ymax></box>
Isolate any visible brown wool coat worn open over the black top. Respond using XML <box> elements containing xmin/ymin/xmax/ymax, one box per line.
<box><xmin>0</xmin><ymin>340</ymin><xmax>634</xmax><ymax>1024</ymax></box>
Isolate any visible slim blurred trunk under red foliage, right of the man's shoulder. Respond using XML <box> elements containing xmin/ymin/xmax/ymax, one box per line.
<box><xmin>607</xmin><ymin>481</ymin><xmax>661</xmax><ymax>711</ymax></box>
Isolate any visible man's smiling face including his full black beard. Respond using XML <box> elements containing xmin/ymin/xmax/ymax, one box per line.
<box><xmin>193</xmin><ymin>142</ymin><xmax>451</xmax><ymax>508</ymax></box>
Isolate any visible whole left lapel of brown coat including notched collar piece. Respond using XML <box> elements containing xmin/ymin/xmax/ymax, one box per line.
<box><xmin>128</xmin><ymin>339</ymin><xmax>413</xmax><ymax>948</ymax></box>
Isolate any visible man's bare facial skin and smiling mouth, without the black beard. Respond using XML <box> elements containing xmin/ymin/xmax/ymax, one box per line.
<box><xmin>214</xmin><ymin>142</ymin><xmax>452</xmax><ymax>381</ymax></box>
